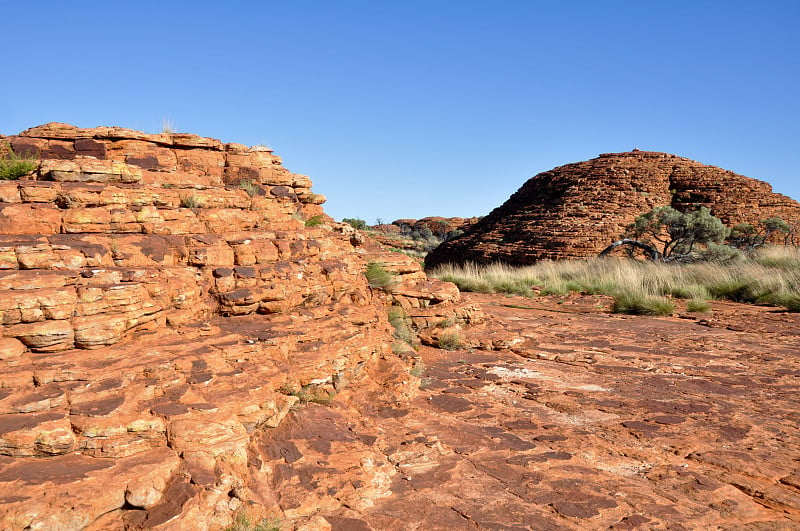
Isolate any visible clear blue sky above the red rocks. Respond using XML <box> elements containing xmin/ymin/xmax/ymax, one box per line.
<box><xmin>0</xmin><ymin>0</ymin><xmax>800</xmax><ymax>223</ymax></box>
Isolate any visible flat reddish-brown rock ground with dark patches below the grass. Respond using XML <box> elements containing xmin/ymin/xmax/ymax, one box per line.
<box><xmin>275</xmin><ymin>294</ymin><xmax>800</xmax><ymax>530</ymax></box>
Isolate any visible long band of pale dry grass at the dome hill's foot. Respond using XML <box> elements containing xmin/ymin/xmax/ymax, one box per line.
<box><xmin>430</xmin><ymin>246</ymin><xmax>800</xmax><ymax>315</ymax></box>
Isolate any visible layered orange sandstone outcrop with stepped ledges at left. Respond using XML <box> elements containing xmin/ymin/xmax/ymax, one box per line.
<box><xmin>0</xmin><ymin>123</ymin><xmax>459</xmax><ymax>530</ymax></box>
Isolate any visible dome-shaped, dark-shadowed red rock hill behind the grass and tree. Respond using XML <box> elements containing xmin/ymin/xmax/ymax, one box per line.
<box><xmin>426</xmin><ymin>150</ymin><xmax>800</xmax><ymax>267</ymax></box>
